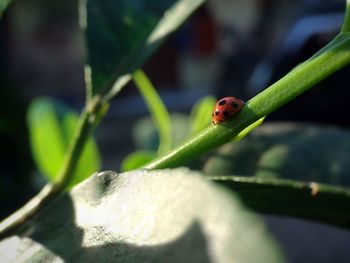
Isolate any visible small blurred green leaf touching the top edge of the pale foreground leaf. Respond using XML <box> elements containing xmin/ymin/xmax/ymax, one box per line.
<box><xmin>121</xmin><ymin>151</ymin><xmax>157</xmax><ymax>171</ymax></box>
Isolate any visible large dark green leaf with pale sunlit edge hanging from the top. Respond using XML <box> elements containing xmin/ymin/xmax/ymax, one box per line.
<box><xmin>81</xmin><ymin>0</ymin><xmax>204</xmax><ymax>97</ymax></box>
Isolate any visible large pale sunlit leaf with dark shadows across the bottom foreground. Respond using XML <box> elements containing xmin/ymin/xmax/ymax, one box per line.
<box><xmin>0</xmin><ymin>169</ymin><xmax>283</xmax><ymax>263</ymax></box>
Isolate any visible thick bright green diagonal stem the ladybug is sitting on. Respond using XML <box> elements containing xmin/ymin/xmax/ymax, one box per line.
<box><xmin>144</xmin><ymin>33</ymin><xmax>350</xmax><ymax>169</ymax></box>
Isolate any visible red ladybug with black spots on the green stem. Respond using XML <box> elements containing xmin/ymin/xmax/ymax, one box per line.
<box><xmin>212</xmin><ymin>97</ymin><xmax>244</xmax><ymax>124</ymax></box>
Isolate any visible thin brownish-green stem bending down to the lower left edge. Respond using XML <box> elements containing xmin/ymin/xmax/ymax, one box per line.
<box><xmin>0</xmin><ymin>107</ymin><xmax>98</xmax><ymax>238</ymax></box>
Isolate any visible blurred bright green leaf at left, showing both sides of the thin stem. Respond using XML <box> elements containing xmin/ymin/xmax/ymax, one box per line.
<box><xmin>27</xmin><ymin>98</ymin><xmax>100</xmax><ymax>187</ymax></box>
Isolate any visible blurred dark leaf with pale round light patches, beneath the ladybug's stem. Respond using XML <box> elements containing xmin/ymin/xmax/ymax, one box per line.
<box><xmin>203</xmin><ymin>123</ymin><xmax>350</xmax><ymax>186</ymax></box>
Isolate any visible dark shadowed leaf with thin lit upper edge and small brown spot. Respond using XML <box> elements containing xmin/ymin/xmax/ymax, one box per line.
<box><xmin>207</xmin><ymin>176</ymin><xmax>350</xmax><ymax>229</ymax></box>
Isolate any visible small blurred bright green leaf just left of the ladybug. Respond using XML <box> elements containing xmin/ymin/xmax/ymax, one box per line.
<box><xmin>190</xmin><ymin>96</ymin><xmax>216</xmax><ymax>135</ymax></box>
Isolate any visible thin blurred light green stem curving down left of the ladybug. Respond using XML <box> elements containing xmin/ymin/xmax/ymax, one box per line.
<box><xmin>133</xmin><ymin>70</ymin><xmax>172</xmax><ymax>154</ymax></box>
